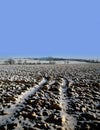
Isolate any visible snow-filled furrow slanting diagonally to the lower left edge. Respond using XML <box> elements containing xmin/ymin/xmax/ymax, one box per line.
<box><xmin>0</xmin><ymin>78</ymin><xmax>47</xmax><ymax>126</ymax></box>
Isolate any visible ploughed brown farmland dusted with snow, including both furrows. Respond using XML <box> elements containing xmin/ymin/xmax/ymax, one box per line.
<box><xmin>0</xmin><ymin>63</ymin><xmax>100</xmax><ymax>130</ymax></box>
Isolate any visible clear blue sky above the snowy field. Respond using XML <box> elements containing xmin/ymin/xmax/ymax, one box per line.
<box><xmin>0</xmin><ymin>0</ymin><xmax>100</xmax><ymax>58</ymax></box>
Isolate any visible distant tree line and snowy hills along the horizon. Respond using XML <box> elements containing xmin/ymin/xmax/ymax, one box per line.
<box><xmin>4</xmin><ymin>57</ymin><xmax>100</xmax><ymax>65</ymax></box>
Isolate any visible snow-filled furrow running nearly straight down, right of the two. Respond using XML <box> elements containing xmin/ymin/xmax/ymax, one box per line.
<box><xmin>60</xmin><ymin>78</ymin><xmax>76</xmax><ymax>130</ymax></box>
